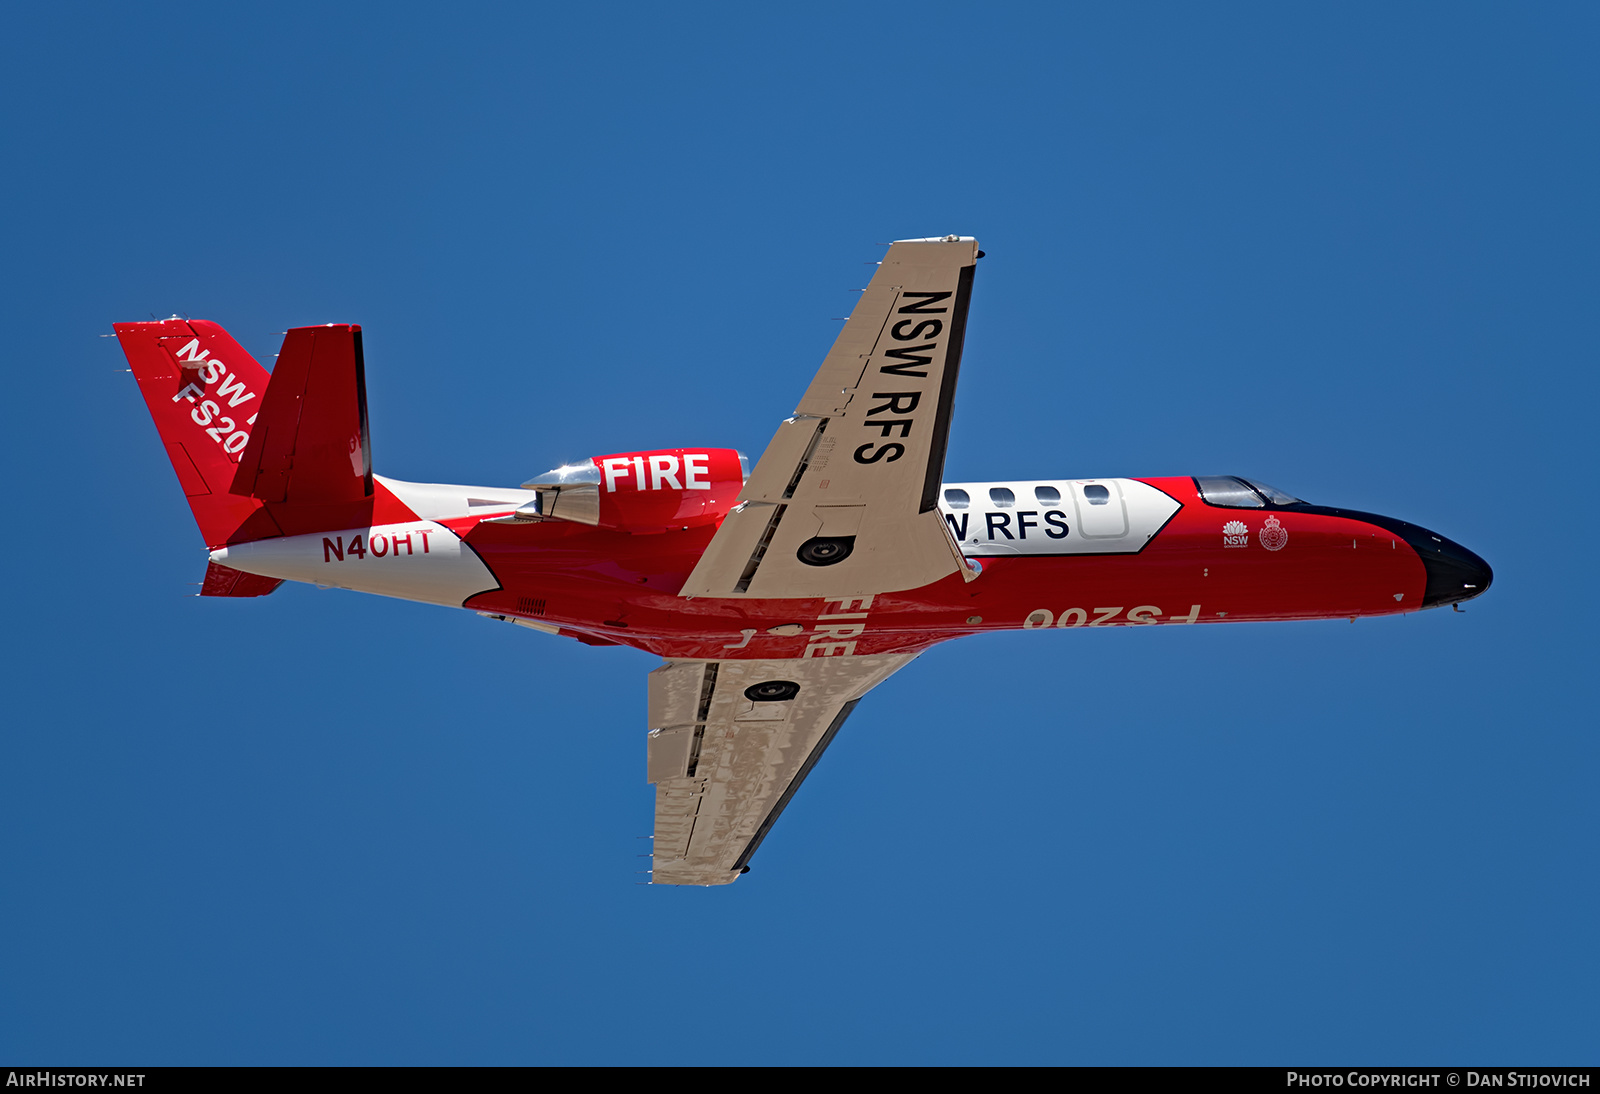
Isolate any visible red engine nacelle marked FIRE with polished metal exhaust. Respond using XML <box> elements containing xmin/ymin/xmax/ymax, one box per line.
<box><xmin>502</xmin><ymin>448</ymin><xmax>749</xmax><ymax>536</ymax></box>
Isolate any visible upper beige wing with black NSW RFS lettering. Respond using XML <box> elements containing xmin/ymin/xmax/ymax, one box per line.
<box><xmin>680</xmin><ymin>235</ymin><xmax>979</xmax><ymax>598</ymax></box>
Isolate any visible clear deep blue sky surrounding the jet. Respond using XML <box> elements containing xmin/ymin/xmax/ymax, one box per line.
<box><xmin>0</xmin><ymin>3</ymin><xmax>1600</xmax><ymax>1064</ymax></box>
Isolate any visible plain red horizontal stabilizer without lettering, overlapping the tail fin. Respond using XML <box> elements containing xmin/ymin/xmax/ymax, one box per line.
<box><xmin>230</xmin><ymin>323</ymin><xmax>373</xmax><ymax>505</ymax></box>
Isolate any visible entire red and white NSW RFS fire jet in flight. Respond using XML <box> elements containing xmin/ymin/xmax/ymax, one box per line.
<box><xmin>115</xmin><ymin>235</ymin><xmax>1491</xmax><ymax>884</ymax></box>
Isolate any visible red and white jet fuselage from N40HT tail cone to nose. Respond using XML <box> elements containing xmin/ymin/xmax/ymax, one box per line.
<box><xmin>211</xmin><ymin>463</ymin><xmax>1490</xmax><ymax>659</ymax></box>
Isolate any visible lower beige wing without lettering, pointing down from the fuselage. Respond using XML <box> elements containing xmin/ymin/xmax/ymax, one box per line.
<box><xmin>646</xmin><ymin>653</ymin><xmax>917</xmax><ymax>884</ymax></box>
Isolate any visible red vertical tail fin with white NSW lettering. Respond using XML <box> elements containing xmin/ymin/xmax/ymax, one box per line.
<box><xmin>114</xmin><ymin>318</ymin><xmax>280</xmax><ymax>547</ymax></box>
